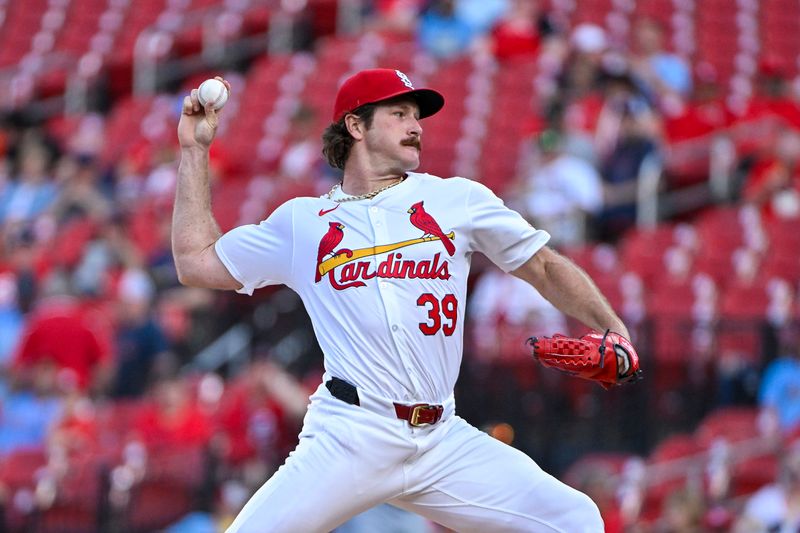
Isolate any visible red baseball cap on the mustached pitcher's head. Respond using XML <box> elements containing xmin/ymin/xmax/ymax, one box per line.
<box><xmin>333</xmin><ymin>68</ymin><xmax>444</xmax><ymax>122</ymax></box>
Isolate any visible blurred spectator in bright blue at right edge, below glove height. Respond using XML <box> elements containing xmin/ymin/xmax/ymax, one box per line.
<box><xmin>758</xmin><ymin>340</ymin><xmax>800</xmax><ymax>435</ymax></box>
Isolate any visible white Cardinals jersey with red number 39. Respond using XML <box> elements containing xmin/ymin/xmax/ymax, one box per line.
<box><xmin>216</xmin><ymin>173</ymin><xmax>550</xmax><ymax>403</ymax></box>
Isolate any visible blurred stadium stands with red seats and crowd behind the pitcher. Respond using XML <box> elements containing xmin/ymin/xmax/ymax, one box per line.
<box><xmin>0</xmin><ymin>0</ymin><xmax>800</xmax><ymax>533</ymax></box>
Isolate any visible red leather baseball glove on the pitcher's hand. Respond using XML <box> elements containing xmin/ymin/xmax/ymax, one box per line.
<box><xmin>528</xmin><ymin>330</ymin><xmax>641</xmax><ymax>389</ymax></box>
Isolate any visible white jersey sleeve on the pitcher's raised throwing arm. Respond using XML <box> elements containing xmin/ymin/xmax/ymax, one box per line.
<box><xmin>214</xmin><ymin>201</ymin><xmax>294</xmax><ymax>295</ymax></box>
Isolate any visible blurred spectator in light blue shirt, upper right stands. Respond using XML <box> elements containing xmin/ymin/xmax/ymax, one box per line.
<box><xmin>632</xmin><ymin>18</ymin><xmax>692</xmax><ymax>109</ymax></box>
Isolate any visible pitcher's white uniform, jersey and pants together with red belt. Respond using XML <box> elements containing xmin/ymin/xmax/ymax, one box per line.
<box><xmin>216</xmin><ymin>172</ymin><xmax>603</xmax><ymax>533</ymax></box>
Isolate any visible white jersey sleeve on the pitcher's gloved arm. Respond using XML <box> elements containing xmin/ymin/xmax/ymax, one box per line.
<box><xmin>467</xmin><ymin>182</ymin><xmax>550</xmax><ymax>272</ymax></box>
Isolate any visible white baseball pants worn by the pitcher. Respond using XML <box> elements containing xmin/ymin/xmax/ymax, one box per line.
<box><xmin>227</xmin><ymin>385</ymin><xmax>604</xmax><ymax>533</ymax></box>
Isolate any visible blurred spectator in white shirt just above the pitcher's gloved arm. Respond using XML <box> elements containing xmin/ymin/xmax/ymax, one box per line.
<box><xmin>523</xmin><ymin>130</ymin><xmax>603</xmax><ymax>246</ymax></box>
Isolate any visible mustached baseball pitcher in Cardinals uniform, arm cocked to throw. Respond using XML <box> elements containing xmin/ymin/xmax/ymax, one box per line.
<box><xmin>172</xmin><ymin>69</ymin><xmax>638</xmax><ymax>533</ymax></box>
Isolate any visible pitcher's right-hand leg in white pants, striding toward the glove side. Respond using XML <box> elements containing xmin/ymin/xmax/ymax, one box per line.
<box><xmin>391</xmin><ymin>417</ymin><xmax>604</xmax><ymax>533</ymax></box>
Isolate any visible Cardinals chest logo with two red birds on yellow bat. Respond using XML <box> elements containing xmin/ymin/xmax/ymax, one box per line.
<box><xmin>314</xmin><ymin>202</ymin><xmax>456</xmax><ymax>290</ymax></box>
